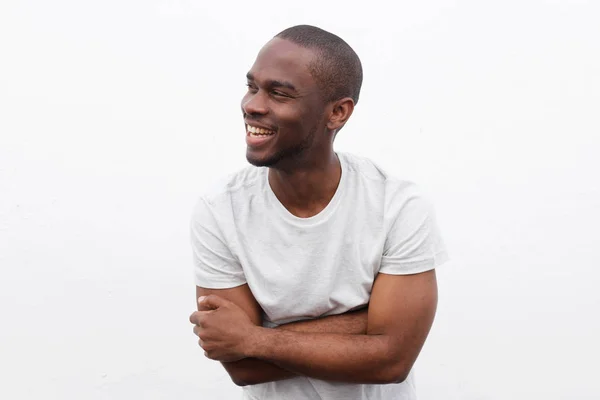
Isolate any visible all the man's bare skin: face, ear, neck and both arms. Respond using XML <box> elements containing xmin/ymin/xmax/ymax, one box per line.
<box><xmin>190</xmin><ymin>38</ymin><xmax>437</xmax><ymax>385</ymax></box>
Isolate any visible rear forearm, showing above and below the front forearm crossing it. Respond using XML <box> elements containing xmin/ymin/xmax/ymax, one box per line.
<box><xmin>222</xmin><ymin>308</ymin><xmax>367</xmax><ymax>386</ymax></box>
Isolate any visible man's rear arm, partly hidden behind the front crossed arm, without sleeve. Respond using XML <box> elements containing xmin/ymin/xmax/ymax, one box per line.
<box><xmin>196</xmin><ymin>284</ymin><xmax>367</xmax><ymax>386</ymax></box>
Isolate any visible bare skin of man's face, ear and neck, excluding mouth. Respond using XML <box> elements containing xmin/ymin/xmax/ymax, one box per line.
<box><xmin>242</xmin><ymin>38</ymin><xmax>354</xmax><ymax>218</ymax></box>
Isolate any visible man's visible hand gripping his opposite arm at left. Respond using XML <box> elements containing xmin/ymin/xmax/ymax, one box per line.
<box><xmin>190</xmin><ymin>294</ymin><xmax>257</xmax><ymax>362</ymax></box>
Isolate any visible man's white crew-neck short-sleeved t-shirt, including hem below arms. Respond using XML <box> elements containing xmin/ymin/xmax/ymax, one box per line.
<box><xmin>191</xmin><ymin>153</ymin><xmax>447</xmax><ymax>400</ymax></box>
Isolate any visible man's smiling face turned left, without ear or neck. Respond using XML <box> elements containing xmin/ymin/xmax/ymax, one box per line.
<box><xmin>242</xmin><ymin>38</ymin><xmax>327</xmax><ymax>167</ymax></box>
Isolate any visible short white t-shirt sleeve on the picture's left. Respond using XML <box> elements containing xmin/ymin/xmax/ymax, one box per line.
<box><xmin>190</xmin><ymin>198</ymin><xmax>246</xmax><ymax>289</ymax></box>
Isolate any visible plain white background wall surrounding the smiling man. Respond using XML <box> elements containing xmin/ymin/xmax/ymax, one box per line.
<box><xmin>0</xmin><ymin>0</ymin><xmax>600</xmax><ymax>400</ymax></box>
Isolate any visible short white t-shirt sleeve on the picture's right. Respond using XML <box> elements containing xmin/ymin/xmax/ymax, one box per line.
<box><xmin>379</xmin><ymin>188</ymin><xmax>448</xmax><ymax>275</ymax></box>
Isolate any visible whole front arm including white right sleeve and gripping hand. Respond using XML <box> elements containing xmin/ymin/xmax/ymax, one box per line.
<box><xmin>190</xmin><ymin>187</ymin><xmax>447</xmax><ymax>384</ymax></box>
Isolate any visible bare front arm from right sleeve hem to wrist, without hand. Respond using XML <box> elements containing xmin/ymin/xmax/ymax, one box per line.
<box><xmin>243</xmin><ymin>270</ymin><xmax>437</xmax><ymax>384</ymax></box>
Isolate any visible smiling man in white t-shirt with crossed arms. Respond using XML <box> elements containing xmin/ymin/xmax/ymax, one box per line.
<box><xmin>190</xmin><ymin>25</ymin><xmax>446</xmax><ymax>400</ymax></box>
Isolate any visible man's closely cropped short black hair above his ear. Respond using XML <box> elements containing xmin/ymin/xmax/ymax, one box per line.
<box><xmin>275</xmin><ymin>25</ymin><xmax>362</xmax><ymax>104</ymax></box>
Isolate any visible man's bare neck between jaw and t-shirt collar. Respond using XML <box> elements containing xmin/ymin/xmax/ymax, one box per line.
<box><xmin>269</xmin><ymin>150</ymin><xmax>342</xmax><ymax>218</ymax></box>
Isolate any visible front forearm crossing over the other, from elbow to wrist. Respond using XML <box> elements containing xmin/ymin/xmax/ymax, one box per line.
<box><xmin>248</xmin><ymin>328</ymin><xmax>408</xmax><ymax>384</ymax></box>
